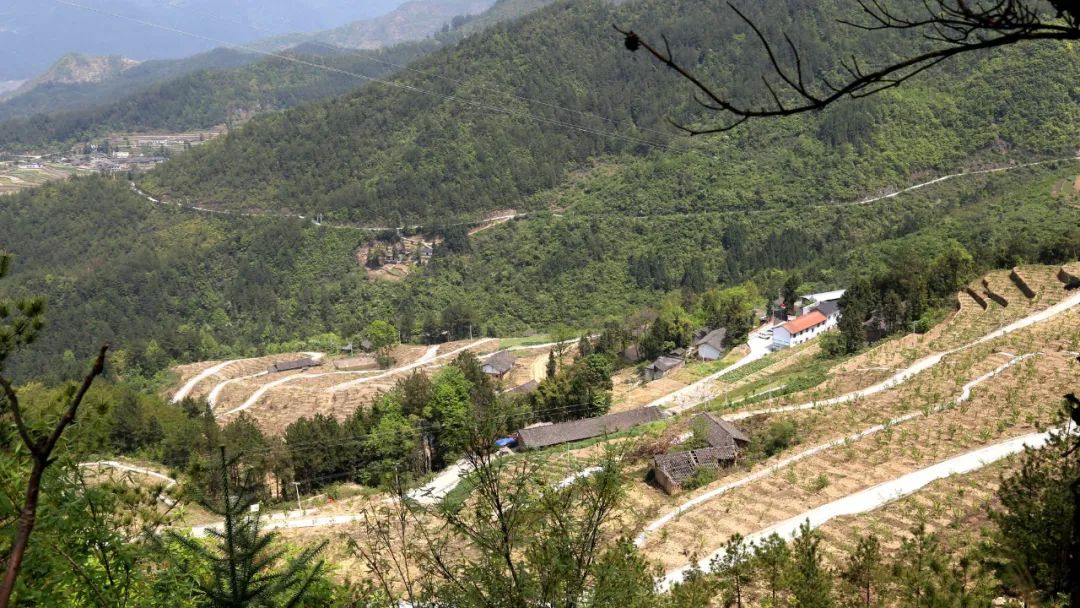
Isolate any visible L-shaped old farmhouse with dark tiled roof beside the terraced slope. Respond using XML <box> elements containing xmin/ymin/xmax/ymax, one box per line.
<box><xmin>652</xmin><ymin>413</ymin><xmax>750</xmax><ymax>494</ymax></box>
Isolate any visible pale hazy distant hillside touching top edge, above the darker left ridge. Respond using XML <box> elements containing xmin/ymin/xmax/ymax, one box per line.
<box><xmin>253</xmin><ymin>0</ymin><xmax>494</xmax><ymax>51</ymax></box>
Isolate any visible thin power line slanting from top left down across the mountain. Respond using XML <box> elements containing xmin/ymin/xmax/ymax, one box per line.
<box><xmin>53</xmin><ymin>0</ymin><xmax>673</xmax><ymax>151</ymax></box>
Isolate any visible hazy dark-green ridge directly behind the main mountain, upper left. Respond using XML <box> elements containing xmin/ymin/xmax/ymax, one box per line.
<box><xmin>0</xmin><ymin>0</ymin><xmax>551</xmax><ymax>151</ymax></box>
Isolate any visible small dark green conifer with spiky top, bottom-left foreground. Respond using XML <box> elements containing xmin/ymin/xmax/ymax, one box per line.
<box><xmin>166</xmin><ymin>446</ymin><xmax>326</xmax><ymax>608</ymax></box>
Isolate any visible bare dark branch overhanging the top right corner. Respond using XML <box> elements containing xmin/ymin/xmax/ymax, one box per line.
<box><xmin>616</xmin><ymin>0</ymin><xmax>1080</xmax><ymax>135</ymax></box>
